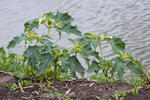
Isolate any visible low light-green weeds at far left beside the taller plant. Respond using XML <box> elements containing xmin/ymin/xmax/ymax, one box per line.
<box><xmin>0</xmin><ymin>48</ymin><xmax>33</xmax><ymax>79</ymax></box>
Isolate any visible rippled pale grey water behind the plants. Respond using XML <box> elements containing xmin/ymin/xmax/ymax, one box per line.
<box><xmin>0</xmin><ymin>0</ymin><xmax>150</xmax><ymax>67</ymax></box>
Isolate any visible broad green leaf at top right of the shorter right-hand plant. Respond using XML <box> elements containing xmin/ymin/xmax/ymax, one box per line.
<box><xmin>109</xmin><ymin>37</ymin><xmax>125</xmax><ymax>52</ymax></box>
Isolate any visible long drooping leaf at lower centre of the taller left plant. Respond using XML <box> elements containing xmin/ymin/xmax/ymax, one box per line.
<box><xmin>38</xmin><ymin>53</ymin><xmax>53</xmax><ymax>75</ymax></box>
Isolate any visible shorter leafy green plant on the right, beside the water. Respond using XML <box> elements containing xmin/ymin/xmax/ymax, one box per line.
<box><xmin>70</xmin><ymin>33</ymin><xmax>143</xmax><ymax>79</ymax></box>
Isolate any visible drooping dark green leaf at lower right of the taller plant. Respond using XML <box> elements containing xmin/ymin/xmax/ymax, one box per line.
<box><xmin>69</xmin><ymin>56</ymin><xmax>85</xmax><ymax>74</ymax></box>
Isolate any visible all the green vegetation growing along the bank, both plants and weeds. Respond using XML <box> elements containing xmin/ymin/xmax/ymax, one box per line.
<box><xmin>0</xmin><ymin>11</ymin><xmax>149</xmax><ymax>100</ymax></box>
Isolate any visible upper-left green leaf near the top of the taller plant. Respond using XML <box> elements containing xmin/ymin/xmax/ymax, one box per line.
<box><xmin>24</xmin><ymin>19</ymin><xmax>39</xmax><ymax>32</ymax></box>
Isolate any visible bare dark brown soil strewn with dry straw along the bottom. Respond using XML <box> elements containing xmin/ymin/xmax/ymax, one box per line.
<box><xmin>0</xmin><ymin>72</ymin><xmax>150</xmax><ymax>100</ymax></box>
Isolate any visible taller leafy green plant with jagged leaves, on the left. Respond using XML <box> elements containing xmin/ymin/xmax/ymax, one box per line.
<box><xmin>7</xmin><ymin>12</ymin><xmax>85</xmax><ymax>80</ymax></box>
